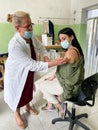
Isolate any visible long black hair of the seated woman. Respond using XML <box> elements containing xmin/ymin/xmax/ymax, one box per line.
<box><xmin>58</xmin><ymin>27</ymin><xmax>84</xmax><ymax>57</ymax></box>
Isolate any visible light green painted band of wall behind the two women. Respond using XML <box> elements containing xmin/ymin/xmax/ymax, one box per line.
<box><xmin>0</xmin><ymin>23</ymin><xmax>86</xmax><ymax>53</ymax></box>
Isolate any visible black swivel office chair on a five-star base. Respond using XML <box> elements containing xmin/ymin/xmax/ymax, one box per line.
<box><xmin>52</xmin><ymin>73</ymin><xmax>98</xmax><ymax>130</ymax></box>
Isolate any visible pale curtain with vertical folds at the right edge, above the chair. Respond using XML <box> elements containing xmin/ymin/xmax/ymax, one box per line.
<box><xmin>85</xmin><ymin>18</ymin><xmax>98</xmax><ymax>77</ymax></box>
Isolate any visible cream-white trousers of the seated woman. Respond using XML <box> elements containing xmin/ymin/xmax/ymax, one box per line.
<box><xmin>35</xmin><ymin>75</ymin><xmax>63</xmax><ymax>104</ymax></box>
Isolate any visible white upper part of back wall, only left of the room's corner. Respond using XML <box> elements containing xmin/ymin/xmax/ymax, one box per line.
<box><xmin>0</xmin><ymin>0</ymin><xmax>70</xmax><ymax>23</ymax></box>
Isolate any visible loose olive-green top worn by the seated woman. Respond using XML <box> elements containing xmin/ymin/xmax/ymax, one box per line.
<box><xmin>56</xmin><ymin>56</ymin><xmax>84</xmax><ymax>102</ymax></box>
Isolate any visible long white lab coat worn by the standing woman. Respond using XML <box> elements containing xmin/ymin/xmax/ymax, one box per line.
<box><xmin>4</xmin><ymin>33</ymin><xmax>48</xmax><ymax>111</ymax></box>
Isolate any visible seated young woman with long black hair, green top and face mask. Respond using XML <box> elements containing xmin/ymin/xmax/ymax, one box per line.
<box><xmin>35</xmin><ymin>28</ymin><xmax>84</xmax><ymax>115</ymax></box>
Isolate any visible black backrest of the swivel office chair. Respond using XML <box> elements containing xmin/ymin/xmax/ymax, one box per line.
<box><xmin>81</xmin><ymin>73</ymin><xmax>98</xmax><ymax>106</ymax></box>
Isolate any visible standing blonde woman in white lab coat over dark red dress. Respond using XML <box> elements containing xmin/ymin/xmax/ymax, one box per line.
<box><xmin>4</xmin><ymin>11</ymin><xmax>65</xmax><ymax>129</ymax></box>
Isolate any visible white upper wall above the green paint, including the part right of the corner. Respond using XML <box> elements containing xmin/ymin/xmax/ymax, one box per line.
<box><xmin>0</xmin><ymin>0</ymin><xmax>98</xmax><ymax>24</ymax></box>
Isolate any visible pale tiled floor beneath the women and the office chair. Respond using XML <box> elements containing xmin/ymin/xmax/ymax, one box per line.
<box><xmin>0</xmin><ymin>67</ymin><xmax>98</xmax><ymax>130</ymax></box>
